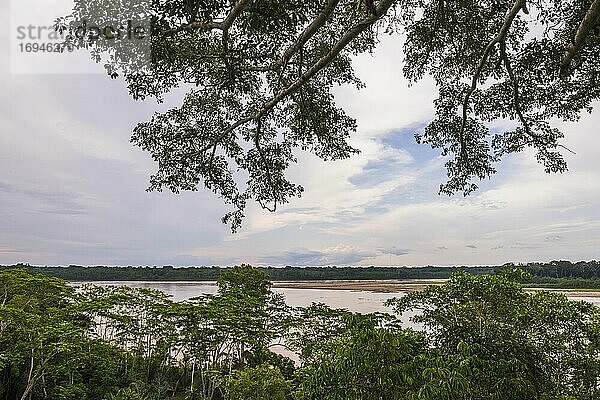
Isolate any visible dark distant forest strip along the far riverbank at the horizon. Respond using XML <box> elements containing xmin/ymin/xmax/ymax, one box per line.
<box><xmin>0</xmin><ymin>261</ymin><xmax>600</xmax><ymax>289</ymax></box>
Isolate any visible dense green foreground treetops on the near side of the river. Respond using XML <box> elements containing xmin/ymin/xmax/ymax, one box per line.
<box><xmin>0</xmin><ymin>266</ymin><xmax>600</xmax><ymax>400</ymax></box>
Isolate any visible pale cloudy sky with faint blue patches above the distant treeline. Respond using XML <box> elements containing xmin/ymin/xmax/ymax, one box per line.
<box><xmin>0</xmin><ymin>0</ymin><xmax>600</xmax><ymax>266</ymax></box>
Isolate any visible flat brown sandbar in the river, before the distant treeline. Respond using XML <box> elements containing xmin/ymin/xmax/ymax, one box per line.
<box><xmin>273</xmin><ymin>279</ymin><xmax>600</xmax><ymax>297</ymax></box>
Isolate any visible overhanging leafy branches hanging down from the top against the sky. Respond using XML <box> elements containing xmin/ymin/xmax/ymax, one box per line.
<box><xmin>57</xmin><ymin>0</ymin><xmax>600</xmax><ymax>230</ymax></box>
